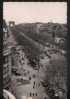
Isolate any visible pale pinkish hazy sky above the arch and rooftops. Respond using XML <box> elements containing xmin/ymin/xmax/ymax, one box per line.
<box><xmin>3</xmin><ymin>2</ymin><xmax>67</xmax><ymax>24</ymax></box>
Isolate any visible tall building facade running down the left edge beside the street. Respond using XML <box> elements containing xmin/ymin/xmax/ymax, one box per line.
<box><xmin>3</xmin><ymin>20</ymin><xmax>11</xmax><ymax>90</ymax></box>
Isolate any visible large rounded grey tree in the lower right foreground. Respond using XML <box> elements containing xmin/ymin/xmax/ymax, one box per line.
<box><xmin>43</xmin><ymin>55</ymin><xmax>67</xmax><ymax>99</ymax></box>
